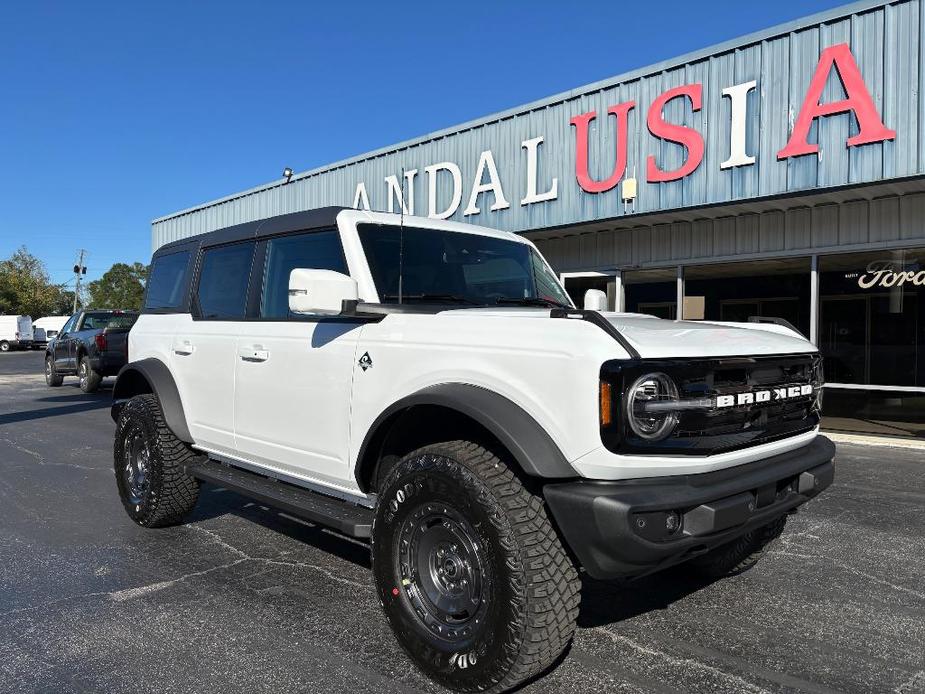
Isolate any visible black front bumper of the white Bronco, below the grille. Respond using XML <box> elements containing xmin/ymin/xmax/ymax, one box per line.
<box><xmin>543</xmin><ymin>436</ymin><xmax>835</xmax><ymax>579</ymax></box>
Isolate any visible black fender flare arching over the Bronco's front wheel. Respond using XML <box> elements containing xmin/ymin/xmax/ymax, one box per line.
<box><xmin>356</xmin><ymin>383</ymin><xmax>578</xmax><ymax>485</ymax></box>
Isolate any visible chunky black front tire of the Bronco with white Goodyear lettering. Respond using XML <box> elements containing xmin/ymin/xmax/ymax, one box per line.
<box><xmin>372</xmin><ymin>441</ymin><xmax>581</xmax><ymax>692</ymax></box>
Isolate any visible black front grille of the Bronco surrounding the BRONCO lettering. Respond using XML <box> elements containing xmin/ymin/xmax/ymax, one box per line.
<box><xmin>601</xmin><ymin>354</ymin><xmax>822</xmax><ymax>455</ymax></box>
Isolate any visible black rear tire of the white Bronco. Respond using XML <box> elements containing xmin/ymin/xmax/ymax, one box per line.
<box><xmin>113</xmin><ymin>394</ymin><xmax>202</xmax><ymax>528</ymax></box>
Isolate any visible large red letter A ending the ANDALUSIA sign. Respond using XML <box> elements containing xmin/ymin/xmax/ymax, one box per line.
<box><xmin>777</xmin><ymin>43</ymin><xmax>896</xmax><ymax>159</ymax></box>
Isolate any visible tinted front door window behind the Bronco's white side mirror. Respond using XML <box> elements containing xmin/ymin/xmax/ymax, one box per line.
<box><xmin>260</xmin><ymin>231</ymin><xmax>347</xmax><ymax>318</ymax></box>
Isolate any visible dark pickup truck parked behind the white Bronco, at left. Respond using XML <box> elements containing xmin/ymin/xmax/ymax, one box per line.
<box><xmin>45</xmin><ymin>309</ymin><xmax>138</xmax><ymax>393</ymax></box>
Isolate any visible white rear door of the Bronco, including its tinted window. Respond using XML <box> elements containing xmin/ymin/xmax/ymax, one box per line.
<box><xmin>170</xmin><ymin>240</ymin><xmax>256</xmax><ymax>454</ymax></box>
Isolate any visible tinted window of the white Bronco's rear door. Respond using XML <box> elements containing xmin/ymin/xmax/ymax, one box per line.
<box><xmin>197</xmin><ymin>243</ymin><xmax>254</xmax><ymax>319</ymax></box>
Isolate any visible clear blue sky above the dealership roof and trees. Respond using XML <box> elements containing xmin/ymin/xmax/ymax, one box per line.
<box><xmin>0</xmin><ymin>0</ymin><xmax>843</xmax><ymax>282</ymax></box>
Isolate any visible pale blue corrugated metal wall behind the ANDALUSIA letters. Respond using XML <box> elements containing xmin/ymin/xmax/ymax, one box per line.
<box><xmin>152</xmin><ymin>0</ymin><xmax>925</xmax><ymax>253</ymax></box>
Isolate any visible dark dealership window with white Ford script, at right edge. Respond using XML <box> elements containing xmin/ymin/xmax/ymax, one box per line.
<box><xmin>818</xmin><ymin>248</ymin><xmax>925</xmax><ymax>437</ymax></box>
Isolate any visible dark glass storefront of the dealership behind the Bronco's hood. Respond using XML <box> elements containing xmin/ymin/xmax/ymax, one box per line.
<box><xmin>608</xmin><ymin>249</ymin><xmax>925</xmax><ymax>438</ymax></box>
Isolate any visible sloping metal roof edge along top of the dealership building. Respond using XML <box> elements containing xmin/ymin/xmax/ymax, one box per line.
<box><xmin>151</xmin><ymin>0</ymin><xmax>888</xmax><ymax>225</ymax></box>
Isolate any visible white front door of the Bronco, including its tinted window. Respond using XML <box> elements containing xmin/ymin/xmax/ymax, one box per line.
<box><xmin>235</xmin><ymin>229</ymin><xmax>363</xmax><ymax>487</ymax></box>
